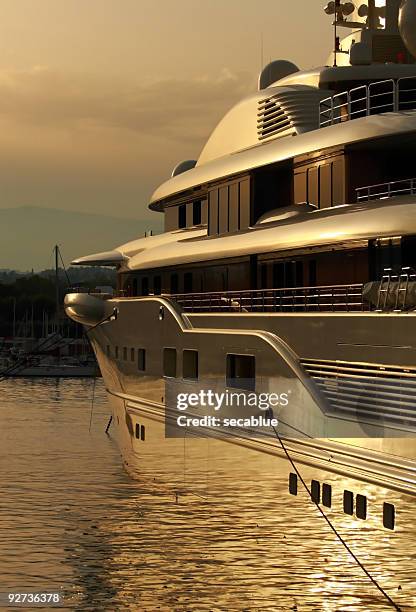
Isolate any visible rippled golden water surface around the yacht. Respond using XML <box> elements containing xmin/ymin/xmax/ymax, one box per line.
<box><xmin>0</xmin><ymin>380</ymin><xmax>416</xmax><ymax>611</ymax></box>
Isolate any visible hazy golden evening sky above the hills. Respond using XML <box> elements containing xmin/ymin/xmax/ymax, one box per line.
<box><xmin>0</xmin><ymin>0</ymin><xmax>332</xmax><ymax>218</ymax></box>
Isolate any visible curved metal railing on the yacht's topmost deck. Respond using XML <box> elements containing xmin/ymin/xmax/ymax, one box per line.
<box><xmin>319</xmin><ymin>76</ymin><xmax>416</xmax><ymax>128</ymax></box>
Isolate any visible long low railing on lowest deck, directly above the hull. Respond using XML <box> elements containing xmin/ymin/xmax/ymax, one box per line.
<box><xmin>169</xmin><ymin>284</ymin><xmax>370</xmax><ymax>313</ymax></box>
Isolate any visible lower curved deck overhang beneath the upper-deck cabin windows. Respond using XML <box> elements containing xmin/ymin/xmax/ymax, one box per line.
<box><xmin>126</xmin><ymin>196</ymin><xmax>416</xmax><ymax>270</ymax></box>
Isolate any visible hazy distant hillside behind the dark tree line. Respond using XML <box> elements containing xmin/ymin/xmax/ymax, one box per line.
<box><xmin>0</xmin><ymin>206</ymin><xmax>162</xmax><ymax>270</ymax></box>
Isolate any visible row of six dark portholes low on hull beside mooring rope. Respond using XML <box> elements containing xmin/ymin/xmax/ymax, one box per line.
<box><xmin>289</xmin><ymin>473</ymin><xmax>395</xmax><ymax>529</ymax></box>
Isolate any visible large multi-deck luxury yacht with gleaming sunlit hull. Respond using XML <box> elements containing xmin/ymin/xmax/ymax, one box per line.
<box><xmin>66</xmin><ymin>0</ymin><xmax>416</xmax><ymax>604</ymax></box>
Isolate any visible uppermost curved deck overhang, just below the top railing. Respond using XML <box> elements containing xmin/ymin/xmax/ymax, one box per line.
<box><xmin>149</xmin><ymin>111</ymin><xmax>416</xmax><ymax>211</ymax></box>
